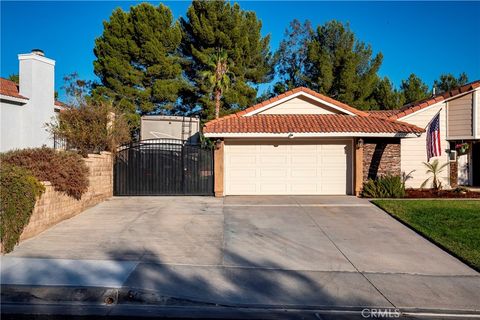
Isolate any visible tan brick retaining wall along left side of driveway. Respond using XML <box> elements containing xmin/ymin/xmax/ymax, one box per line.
<box><xmin>20</xmin><ymin>152</ymin><xmax>113</xmax><ymax>240</ymax></box>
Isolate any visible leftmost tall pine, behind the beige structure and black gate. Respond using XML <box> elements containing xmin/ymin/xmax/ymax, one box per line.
<box><xmin>94</xmin><ymin>3</ymin><xmax>187</xmax><ymax>126</ymax></box>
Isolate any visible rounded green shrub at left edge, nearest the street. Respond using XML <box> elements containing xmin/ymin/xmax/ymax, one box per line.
<box><xmin>0</xmin><ymin>163</ymin><xmax>45</xmax><ymax>252</ymax></box>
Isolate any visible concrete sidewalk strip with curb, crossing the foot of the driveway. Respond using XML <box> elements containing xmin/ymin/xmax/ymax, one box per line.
<box><xmin>1</xmin><ymin>257</ymin><xmax>480</xmax><ymax>315</ymax></box>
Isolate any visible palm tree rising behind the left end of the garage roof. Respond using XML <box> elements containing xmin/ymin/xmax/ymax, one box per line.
<box><xmin>202</xmin><ymin>51</ymin><xmax>232</xmax><ymax>119</ymax></box>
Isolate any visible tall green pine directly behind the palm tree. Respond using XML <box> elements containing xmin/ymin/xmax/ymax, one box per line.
<box><xmin>180</xmin><ymin>1</ymin><xmax>272</xmax><ymax>119</ymax></box>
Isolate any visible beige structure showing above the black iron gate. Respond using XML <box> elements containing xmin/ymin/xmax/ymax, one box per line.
<box><xmin>140</xmin><ymin>115</ymin><xmax>200</xmax><ymax>143</ymax></box>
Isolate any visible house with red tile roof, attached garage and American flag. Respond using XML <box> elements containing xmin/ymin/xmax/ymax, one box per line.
<box><xmin>203</xmin><ymin>81</ymin><xmax>480</xmax><ymax>196</ymax></box>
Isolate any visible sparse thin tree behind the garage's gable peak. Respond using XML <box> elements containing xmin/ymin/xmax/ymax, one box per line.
<box><xmin>273</xmin><ymin>19</ymin><xmax>313</xmax><ymax>94</ymax></box>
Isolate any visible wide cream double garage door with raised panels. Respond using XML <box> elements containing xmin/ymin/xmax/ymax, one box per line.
<box><xmin>225</xmin><ymin>140</ymin><xmax>352</xmax><ymax>195</ymax></box>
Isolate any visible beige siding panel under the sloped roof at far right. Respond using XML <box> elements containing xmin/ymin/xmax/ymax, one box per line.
<box><xmin>447</xmin><ymin>93</ymin><xmax>473</xmax><ymax>138</ymax></box>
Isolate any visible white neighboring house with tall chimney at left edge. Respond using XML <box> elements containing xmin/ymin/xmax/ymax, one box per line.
<box><xmin>0</xmin><ymin>50</ymin><xmax>65</xmax><ymax>152</ymax></box>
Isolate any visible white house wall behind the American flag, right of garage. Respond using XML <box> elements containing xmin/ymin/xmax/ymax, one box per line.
<box><xmin>398</xmin><ymin>103</ymin><xmax>450</xmax><ymax>188</ymax></box>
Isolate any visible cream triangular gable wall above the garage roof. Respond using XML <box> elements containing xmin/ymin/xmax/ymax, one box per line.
<box><xmin>261</xmin><ymin>96</ymin><xmax>339</xmax><ymax>114</ymax></box>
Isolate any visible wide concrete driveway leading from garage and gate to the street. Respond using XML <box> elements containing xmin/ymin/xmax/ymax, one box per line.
<box><xmin>2</xmin><ymin>196</ymin><xmax>480</xmax><ymax>311</ymax></box>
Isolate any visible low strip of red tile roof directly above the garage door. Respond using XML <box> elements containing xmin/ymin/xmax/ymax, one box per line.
<box><xmin>203</xmin><ymin>114</ymin><xmax>424</xmax><ymax>134</ymax></box>
